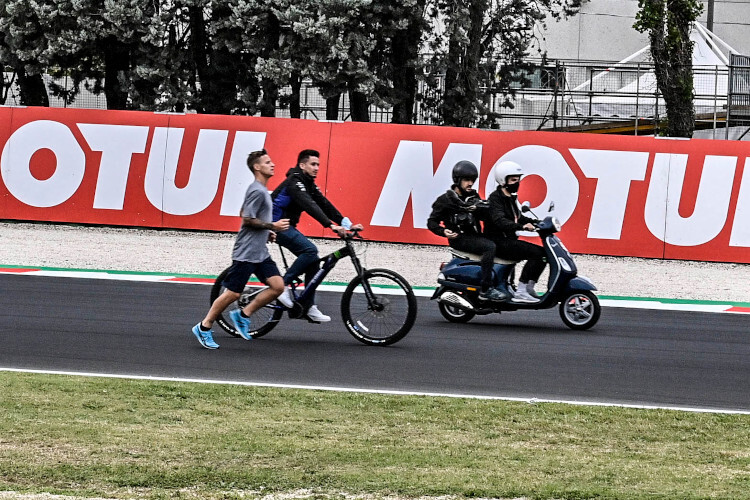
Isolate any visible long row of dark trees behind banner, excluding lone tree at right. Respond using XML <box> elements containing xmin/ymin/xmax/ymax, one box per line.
<box><xmin>0</xmin><ymin>0</ymin><xmax>581</xmax><ymax>126</ymax></box>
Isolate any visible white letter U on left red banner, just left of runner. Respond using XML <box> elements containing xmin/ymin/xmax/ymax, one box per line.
<box><xmin>144</xmin><ymin>127</ymin><xmax>229</xmax><ymax>215</ymax></box>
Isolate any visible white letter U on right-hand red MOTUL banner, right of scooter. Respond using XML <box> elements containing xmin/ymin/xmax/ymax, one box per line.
<box><xmin>644</xmin><ymin>153</ymin><xmax>737</xmax><ymax>246</ymax></box>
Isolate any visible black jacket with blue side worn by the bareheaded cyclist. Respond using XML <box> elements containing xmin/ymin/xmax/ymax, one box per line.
<box><xmin>271</xmin><ymin>167</ymin><xmax>344</xmax><ymax>227</ymax></box>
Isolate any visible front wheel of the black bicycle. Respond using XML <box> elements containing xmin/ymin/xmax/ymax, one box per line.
<box><xmin>341</xmin><ymin>269</ymin><xmax>417</xmax><ymax>345</ymax></box>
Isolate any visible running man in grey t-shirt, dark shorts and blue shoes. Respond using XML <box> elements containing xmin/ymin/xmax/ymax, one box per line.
<box><xmin>193</xmin><ymin>149</ymin><xmax>289</xmax><ymax>349</ymax></box>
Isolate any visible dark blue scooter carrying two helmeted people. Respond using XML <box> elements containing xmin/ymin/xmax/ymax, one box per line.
<box><xmin>432</xmin><ymin>203</ymin><xmax>601</xmax><ymax>330</ymax></box>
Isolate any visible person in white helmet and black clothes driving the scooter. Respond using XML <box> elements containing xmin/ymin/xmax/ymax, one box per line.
<box><xmin>485</xmin><ymin>161</ymin><xmax>546</xmax><ymax>302</ymax></box>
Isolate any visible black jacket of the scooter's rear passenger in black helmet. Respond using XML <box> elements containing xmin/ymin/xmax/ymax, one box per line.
<box><xmin>427</xmin><ymin>189</ymin><xmax>487</xmax><ymax>236</ymax></box>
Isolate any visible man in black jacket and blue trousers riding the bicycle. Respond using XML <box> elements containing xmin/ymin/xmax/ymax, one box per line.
<box><xmin>271</xmin><ymin>149</ymin><xmax>363</xmax><ymax>323</ymax></box>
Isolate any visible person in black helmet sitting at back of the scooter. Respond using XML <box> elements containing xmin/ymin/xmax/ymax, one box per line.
<box><xmin>427</xmin><ymin>160</ymin><xmax>509</xmax><ymax>301</ymax></box>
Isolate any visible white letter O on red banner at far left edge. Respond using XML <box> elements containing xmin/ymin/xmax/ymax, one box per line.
<box><xmin>0</xmin><ymin>120</ymin><xmax>86</xmax><ymax>207</ymax></box>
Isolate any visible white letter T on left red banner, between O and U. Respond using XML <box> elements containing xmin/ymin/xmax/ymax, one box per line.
<box><xmin>78</xmin><ymin>123</ymin><xmax>148</xmax><ymax>210</ymax></box>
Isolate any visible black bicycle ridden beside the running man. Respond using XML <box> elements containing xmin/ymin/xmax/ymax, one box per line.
<box><xmin>211</xmin><ymin>230</ymin><xmax>417</xmax><ymax>345</ymax></box>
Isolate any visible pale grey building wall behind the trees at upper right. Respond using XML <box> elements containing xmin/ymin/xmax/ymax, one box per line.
<box><xmin>541</xmin><ymin>0</ymin><xmax>750</xmax><ymax>61</ymax></box>
